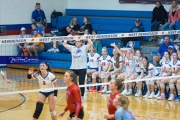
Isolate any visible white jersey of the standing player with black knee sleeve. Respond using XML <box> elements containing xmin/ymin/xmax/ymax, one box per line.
<box><xmin>32</xmin><ymin>72</ymin><xmax>57</xmax><ymax>92</ymax></box>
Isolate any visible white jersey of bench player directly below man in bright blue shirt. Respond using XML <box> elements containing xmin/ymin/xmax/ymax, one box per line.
<box><xmin>161</xmin><ymin>60</ymin><xmax>171</xmax><ymax>76</ymax></box>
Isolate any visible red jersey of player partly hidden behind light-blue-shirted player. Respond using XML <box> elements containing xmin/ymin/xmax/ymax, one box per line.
<box><xmin>107</xmin><ymin>91</ymin><xmax>120</xmax><ymax>120</ymax></box>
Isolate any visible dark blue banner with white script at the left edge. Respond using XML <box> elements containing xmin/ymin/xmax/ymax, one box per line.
<box><xmin>0</xmin><ymin>56</ymin><xmax>40</xmax><ymax>64</ymax></box>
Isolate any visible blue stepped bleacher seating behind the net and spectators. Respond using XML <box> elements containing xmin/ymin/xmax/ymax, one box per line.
<box><xmin>9</xmin><ymin>9</ymin><xmax>155</xmax><ymax>69</ymax></box>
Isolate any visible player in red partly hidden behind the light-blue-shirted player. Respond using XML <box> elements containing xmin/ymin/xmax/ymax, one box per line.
<box><xmin>104</xmin><ymin>79</ymin><xmax>122</xmax><ymax>120</ymax></box>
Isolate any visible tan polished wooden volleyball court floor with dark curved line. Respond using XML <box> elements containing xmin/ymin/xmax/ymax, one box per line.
<box><xmin>0</xmin><ymin>68</ymin><xmax>180</xmax><ymax>120</ymax></box>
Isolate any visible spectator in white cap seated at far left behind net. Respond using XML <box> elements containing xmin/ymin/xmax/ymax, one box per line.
<box><xmin>17</xmin><ymin>27</ymin><xmax>29</xmax><ymax>56</ymax></box>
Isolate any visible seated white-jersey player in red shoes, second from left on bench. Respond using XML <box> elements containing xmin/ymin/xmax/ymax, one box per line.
<box><xmin>91</xmin><ymin>47</ymin><xmax>111</xmax><ymax>93</ymax></box>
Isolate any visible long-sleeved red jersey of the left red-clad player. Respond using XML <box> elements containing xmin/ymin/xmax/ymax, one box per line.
<box><xmin>64</xmin><ymin>84</ymin><xmax>83</xmax><ymax>116</ymax></box>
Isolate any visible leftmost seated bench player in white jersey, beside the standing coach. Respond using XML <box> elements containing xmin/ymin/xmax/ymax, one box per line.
<box><xmin>87</xmin><ymin>46</ymin><xmax>100</xmax><ymax>75</ymax></box>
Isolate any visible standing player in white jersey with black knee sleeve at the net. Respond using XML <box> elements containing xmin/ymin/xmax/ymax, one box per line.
<box><xmin>27</xmin><ymin>62</ymin><xmax>58</xmax><ymax>120</ymax></box>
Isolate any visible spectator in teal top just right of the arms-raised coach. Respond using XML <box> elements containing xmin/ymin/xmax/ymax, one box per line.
<box><xmin>92</xmin><ymin>30</ymin><xmax>102</xmax><ymax>55</ymax></box>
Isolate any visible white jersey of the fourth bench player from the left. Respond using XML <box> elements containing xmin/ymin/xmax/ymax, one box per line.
<box><xmin>124</xmin><ymin>57</ymin><xmax>135</xmax><ymax>73</ymax></box>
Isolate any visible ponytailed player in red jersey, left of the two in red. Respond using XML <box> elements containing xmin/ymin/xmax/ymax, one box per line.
<box><xmin>60</xmin><ymin>70</ymin><xmax>84</xmax><ymax>120</ymax></box>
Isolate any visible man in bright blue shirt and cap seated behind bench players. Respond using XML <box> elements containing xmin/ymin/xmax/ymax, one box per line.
<box><xmin>153</xmin><ymin>36</ymin><xmax>176</xmax><ymax>66</ymax></box>
